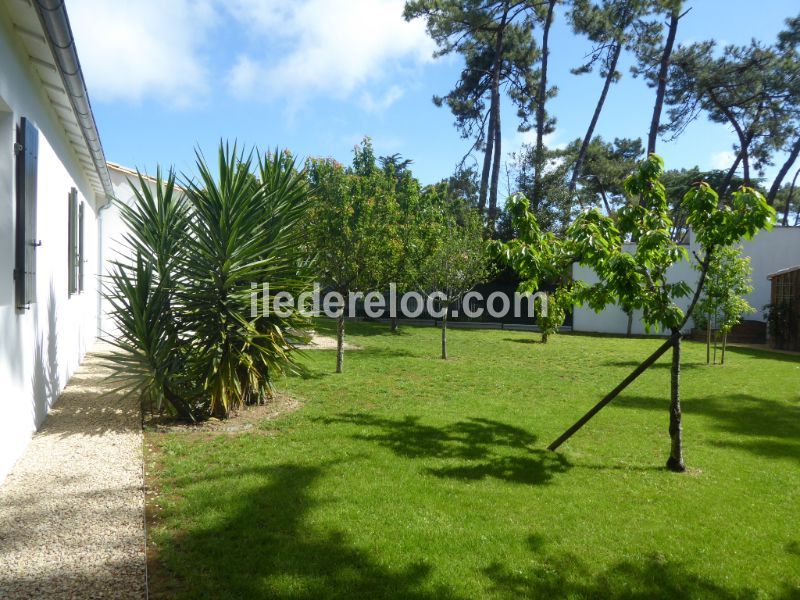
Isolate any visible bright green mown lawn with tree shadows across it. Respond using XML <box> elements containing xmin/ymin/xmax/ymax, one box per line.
<box><xmin>147</xmin><ymin>324</ymin><xmax>800</xmax><ymax>599</ymax></box>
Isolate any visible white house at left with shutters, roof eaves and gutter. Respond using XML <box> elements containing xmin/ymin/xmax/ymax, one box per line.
<box><xmin>0</xmin><ymin>0</ymin><xmax>112</xmax><ymax>481</ymax></box>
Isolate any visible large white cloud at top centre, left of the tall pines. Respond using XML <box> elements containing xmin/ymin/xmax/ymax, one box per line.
<box><xmin>226</xmin><ymin>0</ymin><xmax>433</xmax><ymax>105</ymax></box>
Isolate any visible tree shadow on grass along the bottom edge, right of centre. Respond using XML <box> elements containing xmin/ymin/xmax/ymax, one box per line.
<box><xmin>483</xmin><ymin>536</ymin><xmax>800</xmax><ymax>600</ymax></box>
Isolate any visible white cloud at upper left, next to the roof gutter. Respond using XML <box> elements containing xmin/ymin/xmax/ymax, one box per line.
<box><xmin>69</xmin><ymin>0</ymin><xmax>216</xmax><ymax>105</ymax></box>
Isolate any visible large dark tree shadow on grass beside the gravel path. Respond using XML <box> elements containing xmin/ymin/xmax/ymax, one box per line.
<box><xmin>150</xmin><ymin>464</ymin><xmax>462</xmax><ymax>600</ymax></box>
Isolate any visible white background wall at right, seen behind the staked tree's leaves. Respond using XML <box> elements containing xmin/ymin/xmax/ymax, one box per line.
<box><xmin>572</xmin><ymin>227</ymin><xmax>800</xmax><ymax>335</ymax></box>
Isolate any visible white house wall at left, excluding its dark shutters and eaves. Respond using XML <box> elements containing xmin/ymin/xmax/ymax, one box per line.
<box><xmin>0</xmin><ymin>12</ymin><xmax>98</xmax><ymax>481</ymax></box>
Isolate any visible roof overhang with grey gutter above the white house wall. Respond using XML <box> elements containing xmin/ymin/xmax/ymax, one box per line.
<box><xmin>7</xmin><ymin>0</ymin><xmax>114</xmax><ymax>202</ymax></box>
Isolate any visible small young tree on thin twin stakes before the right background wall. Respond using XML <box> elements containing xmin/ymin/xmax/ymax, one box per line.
<box><xmin>694</xmin><ymin>246</ymin><xmax>756</xmax><ymax>365</ymax></box>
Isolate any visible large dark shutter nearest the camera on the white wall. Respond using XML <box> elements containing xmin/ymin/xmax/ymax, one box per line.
<box><xmin>14</xmin><ymin>117</ymin><xmax>41</xmax><ymax>309</ymax></box>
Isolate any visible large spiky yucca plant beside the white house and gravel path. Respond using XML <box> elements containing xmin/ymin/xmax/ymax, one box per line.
<box><xmin>107</xmin><ymin>144</ymin><xmax>311</xmax><ymax>418</ymax></box>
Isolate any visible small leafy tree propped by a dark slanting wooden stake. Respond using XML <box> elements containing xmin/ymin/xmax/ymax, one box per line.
<box><xmin>512</xmin><ymin>154</ymin><xmax>775</xmax><ymax>471</ymax></box>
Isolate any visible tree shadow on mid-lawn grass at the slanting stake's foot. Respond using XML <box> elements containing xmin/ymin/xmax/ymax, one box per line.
<box><xmin>323</xmin><ymin>413</ymin><xmax>571</xmax><ymax>485</ymax></box>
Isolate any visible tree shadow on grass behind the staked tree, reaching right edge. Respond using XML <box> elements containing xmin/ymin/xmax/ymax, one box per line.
<box><xmin>617</xmin><ymin>394</ymin><xmax>800</xmax><ymax>461</ymax></box>
